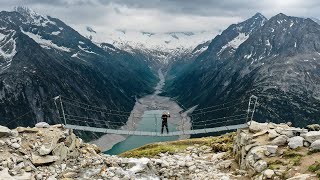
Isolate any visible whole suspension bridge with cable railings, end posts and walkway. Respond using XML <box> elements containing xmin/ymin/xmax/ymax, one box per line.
<box><xmin>54</xmin><ymin>95</ymin><xmax>258</xmax><ymax>136</ymax></box>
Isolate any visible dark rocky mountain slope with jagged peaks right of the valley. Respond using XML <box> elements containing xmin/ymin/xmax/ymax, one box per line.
<box><xmin>167</xmin><ymin>14</ymin><xmax>320</xmax><ymax>126</ymax></box>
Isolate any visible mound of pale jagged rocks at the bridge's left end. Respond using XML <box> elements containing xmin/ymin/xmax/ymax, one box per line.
<box><xmin>0</xmin><ymin>122</ymin><xmax>104</xmax><ymax>180</ymax></box>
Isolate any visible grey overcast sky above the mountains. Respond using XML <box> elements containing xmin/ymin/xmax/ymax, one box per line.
<box><xmin>0</xmin><ymin>0</ymin><xmax>320</xmax><ymax>32</ymax></box>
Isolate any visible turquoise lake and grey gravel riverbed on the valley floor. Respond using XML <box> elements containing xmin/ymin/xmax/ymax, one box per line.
<box><xmin>91</xmin><ymin>69</ymin><xmax>192</xmax><ymax>154</ymax></box>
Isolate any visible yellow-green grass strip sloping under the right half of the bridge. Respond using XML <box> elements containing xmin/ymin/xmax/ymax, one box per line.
<box><xmin>119</xmin><ymin>133</ymin><xmax>235</xmax><ymax>158</ymax></box>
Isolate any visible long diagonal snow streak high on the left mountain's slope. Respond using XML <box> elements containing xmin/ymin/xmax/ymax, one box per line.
<box><xmin>21</xmin><ymin>29</ymin><xmax>71</xmax><ymax>52</ymax></box>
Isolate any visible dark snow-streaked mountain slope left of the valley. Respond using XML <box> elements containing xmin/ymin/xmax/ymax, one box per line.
<box><xmin>0</xmin><ymin>8</ymin><xmax>156</xmax><ymax>126</ymax></box>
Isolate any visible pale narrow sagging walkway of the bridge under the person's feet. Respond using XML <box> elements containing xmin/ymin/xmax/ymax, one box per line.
<box><xmin>65</xmin><ymin>123</ymin><xmax>248</xmax><ymax>136</ymax></box>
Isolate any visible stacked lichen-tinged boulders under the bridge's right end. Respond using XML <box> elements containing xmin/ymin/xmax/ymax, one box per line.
<box><xmin>233</xmin><ymin>121</ymin><xmax>320</xmax><ymax>179</ymax></box>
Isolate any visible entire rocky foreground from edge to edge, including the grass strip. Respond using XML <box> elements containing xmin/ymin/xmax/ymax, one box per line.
<box><xmin>0</xmin><ymin>122</ymin><xmax>320</xmax><ymax>180</ymax></box>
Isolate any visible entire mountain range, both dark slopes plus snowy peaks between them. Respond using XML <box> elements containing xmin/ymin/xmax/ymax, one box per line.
<box><xmin>0</xmin><ymin>7</ymin><xmax>320</xmax><ymax>135</ymax></box>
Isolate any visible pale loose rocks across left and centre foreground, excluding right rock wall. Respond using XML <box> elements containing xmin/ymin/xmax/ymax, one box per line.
<box><xmin>0</xmin><ymin>122</ymin><xmax>240</xmax><ymax>180</ymax></box>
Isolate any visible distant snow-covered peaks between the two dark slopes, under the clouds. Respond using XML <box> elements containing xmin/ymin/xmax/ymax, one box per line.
<box><xmin>77</xmin><ymin>26</ymin><xmax>216</xmax><ymax>50</ymax></box>
